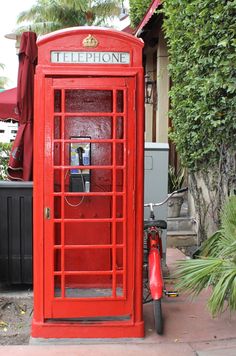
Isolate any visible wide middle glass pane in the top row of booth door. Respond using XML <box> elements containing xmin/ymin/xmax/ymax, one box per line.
<box><xmin>65</xmin><ymin>89</ymin><xmax>113</xmax><ymax>112</ymax></box>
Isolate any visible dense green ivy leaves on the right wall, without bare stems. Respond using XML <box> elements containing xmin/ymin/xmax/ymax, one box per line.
<box><xmin>163</xmin><ymin>0</ymin><xmax>236</xmax><ymax>171</ymax></box>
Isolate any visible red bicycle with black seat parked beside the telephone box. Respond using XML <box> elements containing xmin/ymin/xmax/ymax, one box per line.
<box><xmin>144</xmin><ymin>188</ymin><xmax>188</xmax><ymax>335</ymax></box>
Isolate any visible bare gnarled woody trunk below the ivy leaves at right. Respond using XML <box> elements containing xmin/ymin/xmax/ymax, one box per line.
<box><xmin>189</xmin><ymin>145</ymin><xmax>236</xmax><ymax>243</ymax></box>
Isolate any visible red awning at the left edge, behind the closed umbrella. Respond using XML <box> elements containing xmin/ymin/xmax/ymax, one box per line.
<box><xmin>0</xmin><ymin>88</ymin><xmax>19</xmax><ymax>121</ymax></box>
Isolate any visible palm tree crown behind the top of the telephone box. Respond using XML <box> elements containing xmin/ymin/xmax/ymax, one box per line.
<box><xmin>17</xmin><ymin>0</ymin><xmax>121</xmax><ymax>35</ymax></box>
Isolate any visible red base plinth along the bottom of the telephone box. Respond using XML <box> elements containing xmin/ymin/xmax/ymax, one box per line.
<box><xmin>31</xmin><ymin>320</ymin><xmax>144</xmax><ymax>343</ymax></box>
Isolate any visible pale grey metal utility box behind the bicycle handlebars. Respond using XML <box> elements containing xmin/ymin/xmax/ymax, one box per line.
<box><xmin>144</xmin><ymin>142</ymin><xmax>169</xmax><ymax>263</ymax></box>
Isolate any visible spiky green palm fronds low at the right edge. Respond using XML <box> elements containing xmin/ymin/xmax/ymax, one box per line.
<box><xmin>175</xmin><ymin>196</ymin><xmax>236</xmax><ymax>316</ymax></box>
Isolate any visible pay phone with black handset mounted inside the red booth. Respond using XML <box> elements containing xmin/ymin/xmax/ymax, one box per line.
<box><xmin>69</xmin><ymin>136</ymin><xmax>91</xmax><ymax>192</ymax></box>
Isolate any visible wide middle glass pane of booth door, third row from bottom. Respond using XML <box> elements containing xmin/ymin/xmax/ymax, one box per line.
<box><xmin>65</xmin><ymin>222</ymin><xmax>111</xmax><ymax>245</ymax></box>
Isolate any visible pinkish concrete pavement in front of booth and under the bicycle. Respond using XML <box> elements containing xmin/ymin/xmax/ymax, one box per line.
<box><xmin>0</xmin><ymin>248</ymin><xmax>236</xmax><ymax>356</ymax></box>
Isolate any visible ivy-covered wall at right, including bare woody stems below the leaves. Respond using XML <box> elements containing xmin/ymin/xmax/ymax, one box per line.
<box><xmin>130</xmin><ymin>0</ymin><xmax>236</xmax><ymax>240</ymax></box>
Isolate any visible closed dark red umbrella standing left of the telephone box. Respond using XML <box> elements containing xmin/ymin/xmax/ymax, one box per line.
<box><xmin>8</xmin><ymin>32</ymin><xmax>38</xmax><ymax>180</ymax></box>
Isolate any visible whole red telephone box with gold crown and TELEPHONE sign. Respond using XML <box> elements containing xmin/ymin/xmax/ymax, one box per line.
<box><xmin>32</xmin><ymin>27</ymin><xmax>144</xmax><ymax>338</ymax></box>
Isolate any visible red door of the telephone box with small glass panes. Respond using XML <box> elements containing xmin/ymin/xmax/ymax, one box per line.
<box><xmin>44</xmin><ymin>78</ymin><xmax>135</xmax><ymax>320</ymax></box>
